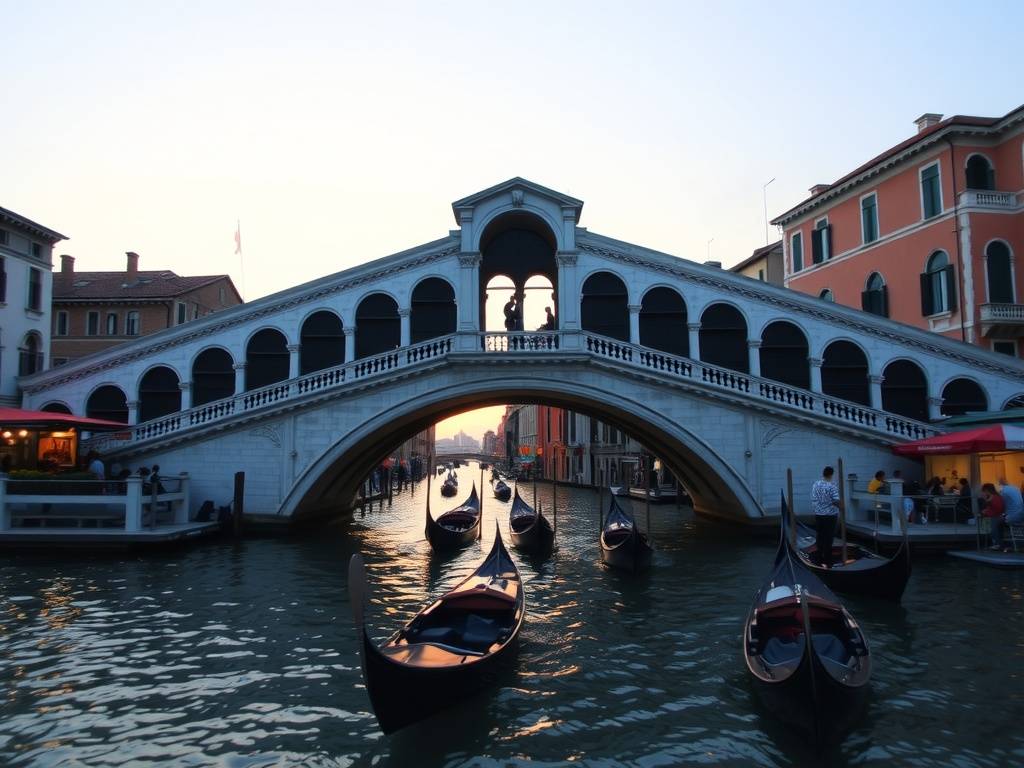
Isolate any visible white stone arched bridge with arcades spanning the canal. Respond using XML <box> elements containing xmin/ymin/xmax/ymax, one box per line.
<box><xmin>20</xmin><ymin>178</ymin><xmax>1024</xmax><ymax>517</ymax></box>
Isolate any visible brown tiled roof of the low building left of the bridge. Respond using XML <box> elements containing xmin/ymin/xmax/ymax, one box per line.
<box><xmin>53</xmin><ymin>269</ymin><xmax>241</xmax><ymax>301</ymax></box>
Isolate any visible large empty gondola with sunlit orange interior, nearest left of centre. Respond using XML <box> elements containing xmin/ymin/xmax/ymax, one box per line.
<box><xmin>348</xmin><ymin>526</ymin><xmax>526</xmax><ymax>733</ymax></box>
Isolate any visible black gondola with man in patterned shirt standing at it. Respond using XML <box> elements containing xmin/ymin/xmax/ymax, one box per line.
<box><xmin>787</xmin><ymin>522</ymin><xmax>911</xmax><ymax>602</ymax></box>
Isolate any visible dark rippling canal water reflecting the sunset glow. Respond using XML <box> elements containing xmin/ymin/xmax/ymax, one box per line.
<box><xmin>0</xmin><ymin>466</ymin><xmax>1024</xmax><ymax>768</ymax></box>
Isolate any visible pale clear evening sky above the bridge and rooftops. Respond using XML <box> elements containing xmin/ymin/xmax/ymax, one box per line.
<box><xmin>0</xmin><ymin>0</ymin><xmax>1024</xmax><ymax>437</ymax></box>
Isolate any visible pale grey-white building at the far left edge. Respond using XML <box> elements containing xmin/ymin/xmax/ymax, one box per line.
<box><xmin>0</xmin><ymin>208</ymin><xmax>67</xmax><ymax>408</ymax></box>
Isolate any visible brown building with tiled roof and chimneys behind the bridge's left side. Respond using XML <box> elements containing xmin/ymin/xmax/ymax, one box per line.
<box><xmin>50</xmin><ymin>251</ymin><xmax>242</xmax><ymax>366</ymax></box>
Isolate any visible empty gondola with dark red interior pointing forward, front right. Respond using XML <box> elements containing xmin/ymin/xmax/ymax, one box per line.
<box><xmin>743</xmin><ymin>501</ymin><xmax>871</xmax><ymax>745</ymax></box>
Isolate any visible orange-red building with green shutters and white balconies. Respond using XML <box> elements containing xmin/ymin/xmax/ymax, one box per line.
<box><xmin>772</xmin><ymin>106</ymin><xmax>1024</xmax><ymax>356</ymax></box>
